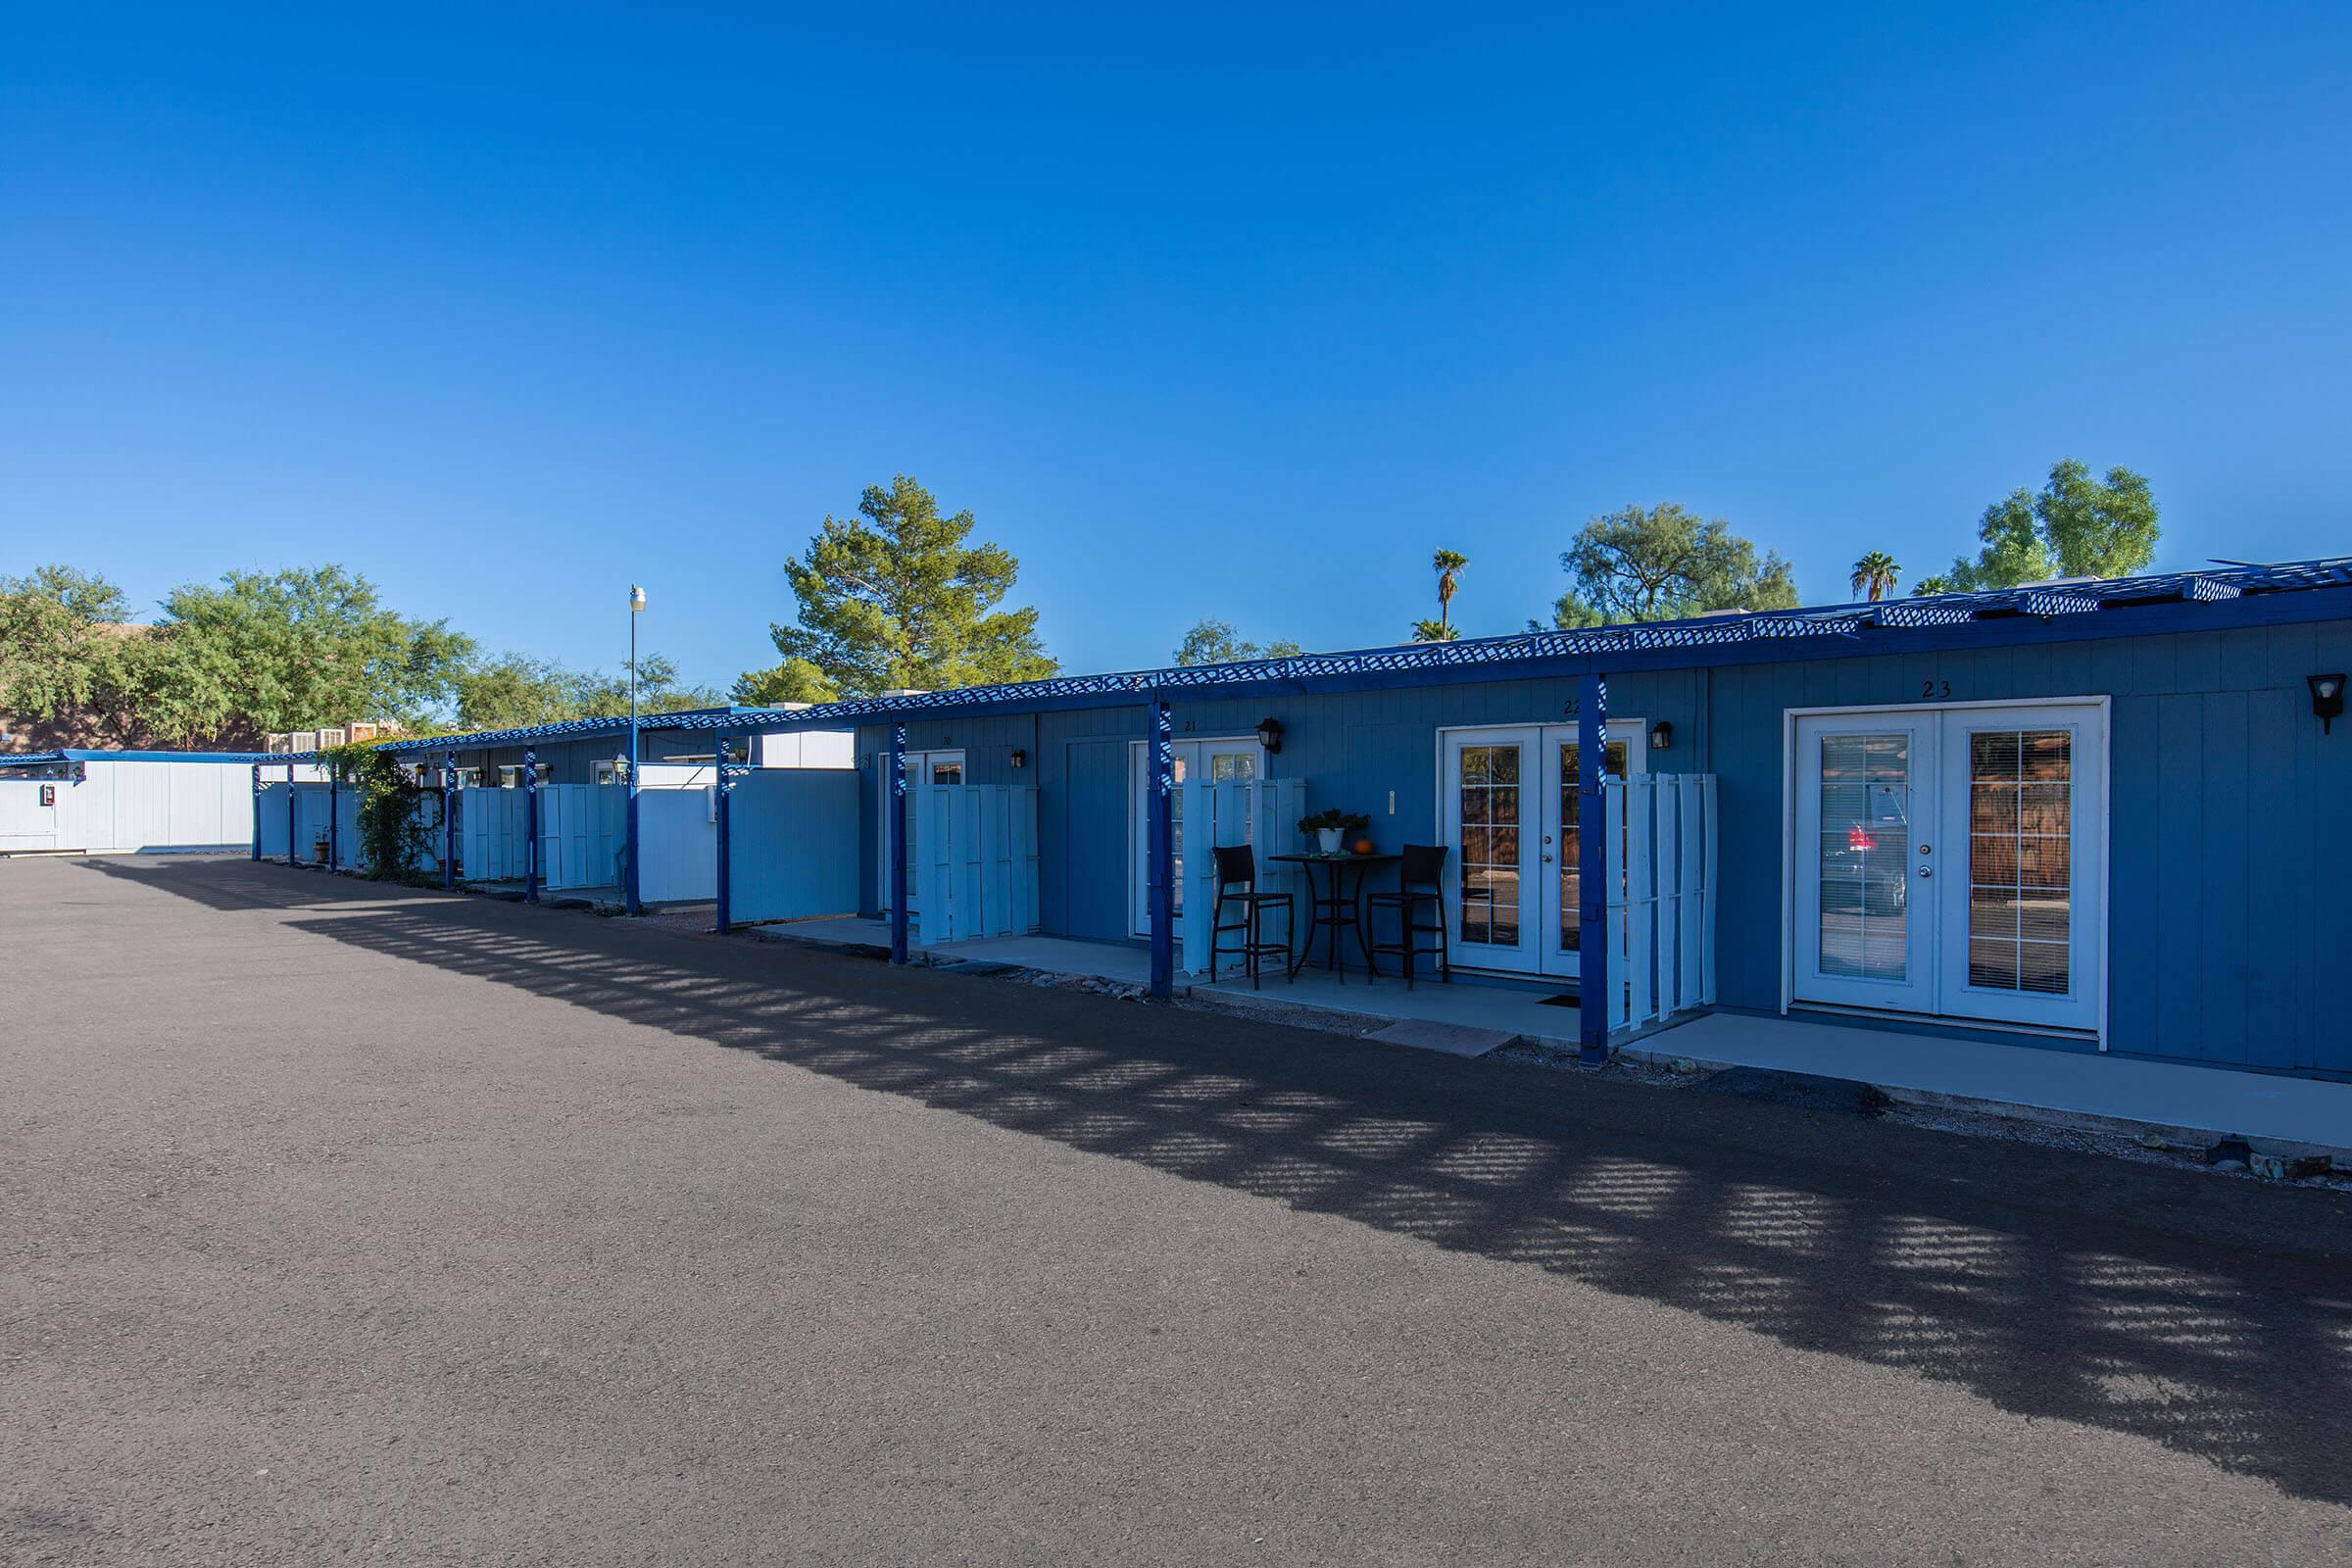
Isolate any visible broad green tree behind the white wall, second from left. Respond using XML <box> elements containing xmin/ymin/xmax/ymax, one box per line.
<box><xmin>136</xmin><ymin>566</ymin><xmax>472</xmax><ymax>743</ymax></box>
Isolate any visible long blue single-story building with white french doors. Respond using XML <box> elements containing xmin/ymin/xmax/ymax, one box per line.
<box><xmin>635</xmin><ymin>560</ymin><xmax>2352</xmax><ymax>1074</ymax></box>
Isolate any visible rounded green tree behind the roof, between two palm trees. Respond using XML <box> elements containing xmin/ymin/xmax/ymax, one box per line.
<box><xmin>1552</xmin><ymin>501</ymin><xmax>1797</xmax><ymax>630</ymax></box>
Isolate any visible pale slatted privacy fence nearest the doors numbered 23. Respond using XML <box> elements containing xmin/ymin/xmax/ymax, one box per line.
<box><xmin>1601</xmin><ymin>773</ymin><xmax>1717</xmax><ymax>1030</ymax></box>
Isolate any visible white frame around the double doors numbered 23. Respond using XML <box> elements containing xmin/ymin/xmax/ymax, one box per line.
<box><xmin>1781</xmin><ymin>696</ymin><xmax>2115</xmax><ymax>1051</ymax></box>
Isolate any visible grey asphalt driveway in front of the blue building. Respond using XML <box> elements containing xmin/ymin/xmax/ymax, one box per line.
<box><xmin>0</xmin><ymin>858</ymin><xmax>2352</xmax><ymax>1563</ymax></box>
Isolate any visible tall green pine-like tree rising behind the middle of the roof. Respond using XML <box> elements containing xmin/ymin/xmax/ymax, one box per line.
<box><xmin>769</xmin><ymin>475</ymin><xmax>1058</xmax><ymax>696</ymax></box>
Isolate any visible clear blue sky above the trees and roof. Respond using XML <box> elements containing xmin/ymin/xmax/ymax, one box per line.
<box><xmin>0</xmin><ymin>2</ymin><xmax>2352</xmax><ymax>684</ymax></box>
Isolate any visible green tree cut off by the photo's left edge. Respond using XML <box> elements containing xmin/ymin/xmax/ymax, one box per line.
<box><xmin>0</xmin><ymin>566</ymin><xmax>146</xmax><ymax>738</ymax></box>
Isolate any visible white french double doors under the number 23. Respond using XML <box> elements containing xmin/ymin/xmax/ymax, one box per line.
<box><xmin>1789</xmin><ymin>703</ymin><xmax>2107</xmax><ymax>1032</ymax></box>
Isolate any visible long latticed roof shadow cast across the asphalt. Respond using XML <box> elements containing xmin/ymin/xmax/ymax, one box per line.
<box><xmin>92</xmin><ymin>860</ymin><xmax>2352</xmax><ymax>1502</ymax></box>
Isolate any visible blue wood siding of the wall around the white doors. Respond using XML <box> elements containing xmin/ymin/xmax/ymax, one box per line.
<box><xmin>837</xmin><ymin>620</ymin><xmax>2352</xmax><ymax>1072</ymax></box>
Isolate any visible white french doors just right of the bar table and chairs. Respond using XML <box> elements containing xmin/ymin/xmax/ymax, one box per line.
<box><xmin>1440</xmin><ymin>719</ymin><xmax>1648</xmax><ymax>976</ymax></box>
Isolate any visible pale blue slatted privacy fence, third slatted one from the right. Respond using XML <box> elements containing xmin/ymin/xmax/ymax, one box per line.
<box><xmin>906</xmin><ymin>785</ymin><xmax>1037</xmax><ymax>945</ymax></box>
